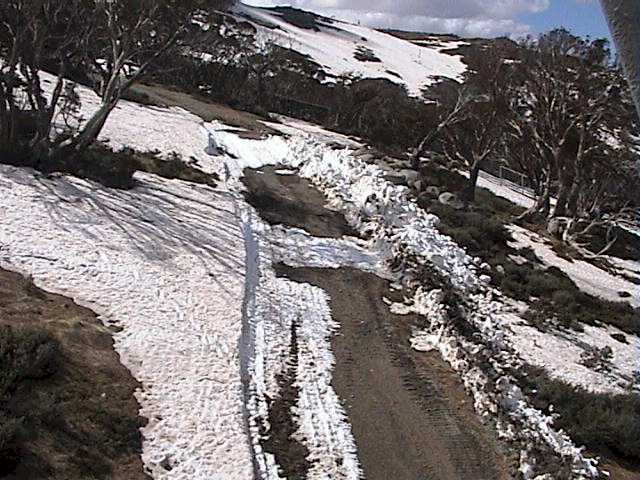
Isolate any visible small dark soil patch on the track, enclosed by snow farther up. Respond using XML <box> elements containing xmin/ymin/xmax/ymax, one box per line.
<box><xmin>242</xmin><ymin>167</ymin><xmax>358</xmax><ymax>238</ymax></box>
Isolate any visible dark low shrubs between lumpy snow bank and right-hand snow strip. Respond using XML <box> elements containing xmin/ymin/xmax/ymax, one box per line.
<box><xmin>420</xmin><ymin>166</ymin><xmax>640</xmax><ymax>334</ymax></box>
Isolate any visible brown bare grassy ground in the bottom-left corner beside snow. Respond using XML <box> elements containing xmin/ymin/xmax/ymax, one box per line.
<box><xmin>0</xmin><ymin>269</ymin><xmax>149</xmax><ymax>480</ymax></box>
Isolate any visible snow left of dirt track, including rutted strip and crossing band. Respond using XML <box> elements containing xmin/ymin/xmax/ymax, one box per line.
<box><xmin>0</xmin><ymin>74</ymin><xmax>370</xmax><ymax>480</ymax></box>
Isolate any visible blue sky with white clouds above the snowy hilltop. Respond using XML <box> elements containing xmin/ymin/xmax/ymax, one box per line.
<box><xmin>244</xmin><ymin>0</ymin><xmax>609</xmax><ymax>38</ymax></box>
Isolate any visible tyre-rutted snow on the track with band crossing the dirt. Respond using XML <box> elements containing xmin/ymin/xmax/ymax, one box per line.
<box><xmin>236</xmin><ymin>192</ymin><xmax>364</xmax><ymax>480</ymax></box>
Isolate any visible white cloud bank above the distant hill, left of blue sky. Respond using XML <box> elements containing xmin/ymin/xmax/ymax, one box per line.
<box><xmin>242</xmin><ymin>0</ymin><xmax>550</xmax><ymax>37</ymax></box>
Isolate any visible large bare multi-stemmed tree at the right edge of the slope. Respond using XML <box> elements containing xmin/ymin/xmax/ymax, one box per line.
<box><xmin>506</xmin><ymin>30</ymin><xmax>637</xmax><ymax>255</ymax></box>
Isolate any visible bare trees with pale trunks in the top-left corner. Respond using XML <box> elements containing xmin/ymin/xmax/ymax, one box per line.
<box><xmin>0</xmin><ymin>0</ymin><xmax>227</xmax><ymax>165</ymax></box>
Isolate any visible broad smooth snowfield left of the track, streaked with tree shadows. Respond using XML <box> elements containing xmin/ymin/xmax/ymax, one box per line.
<box><xmin>0</xmin><ymin>167</ymin><xmax>252</xmax><ymax>480</ymax></box>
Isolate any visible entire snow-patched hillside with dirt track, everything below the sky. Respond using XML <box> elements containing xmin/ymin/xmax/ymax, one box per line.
<box><xmin>0</xmin><ymin>1</ymin><xmax>640</xmax><ymax>480</ymax></box>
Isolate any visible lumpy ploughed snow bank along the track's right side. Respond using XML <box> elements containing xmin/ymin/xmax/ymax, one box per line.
<box><xmin>215</xmin><ymin>129</ymin><xmax>599</xmax><ymax>479</ymax></box>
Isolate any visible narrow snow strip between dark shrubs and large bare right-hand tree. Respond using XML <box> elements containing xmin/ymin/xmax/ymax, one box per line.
<box><xmin>508</xmin><ymin>225</ymin><xmax>640</xmax><ymax>308</ymax></box>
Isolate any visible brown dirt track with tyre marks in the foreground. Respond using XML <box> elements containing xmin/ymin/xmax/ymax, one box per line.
<box><xmin>277</xmin><ymin>265</ymin><xmax>509</xmax><ymax>480</ymax></box>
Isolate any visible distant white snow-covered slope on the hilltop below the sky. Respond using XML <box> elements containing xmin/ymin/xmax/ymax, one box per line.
<box><xmin>234</xmin><ymin>3</ymin><xmax>466</xmax><ymax>96</ymax></box>
